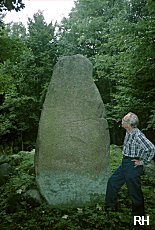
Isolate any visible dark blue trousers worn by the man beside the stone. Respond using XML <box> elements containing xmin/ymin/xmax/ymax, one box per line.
<box><xmin>105</xmin><ymin>159</ymin><xmax>144</xmax><ymax>216</ymax></box>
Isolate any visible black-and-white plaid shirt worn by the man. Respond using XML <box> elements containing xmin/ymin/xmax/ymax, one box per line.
<box><xmin>122</xmin><ymin>128</ymin><xmax>155</xmax><ymax>165</ymax></box>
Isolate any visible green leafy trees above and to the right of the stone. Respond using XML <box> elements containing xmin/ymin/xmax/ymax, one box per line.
<box><xmin>58</xmin><ymin>0</ymin><xmax>155</xmax><ymax>137</ymax></box>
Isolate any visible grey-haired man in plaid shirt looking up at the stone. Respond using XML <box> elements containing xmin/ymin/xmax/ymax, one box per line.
<box><xmin>105</xmin><ymin>112</ymin><xmax>155</xmax><ymax>216</ymax></box>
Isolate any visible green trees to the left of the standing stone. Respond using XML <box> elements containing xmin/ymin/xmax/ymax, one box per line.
<box><xmin>0</xmin><ymin>12</ymin><xmax>57</xmax><ymax>151</ymax></box>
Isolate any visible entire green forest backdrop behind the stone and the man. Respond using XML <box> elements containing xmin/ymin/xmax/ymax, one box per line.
<box><xmin>0</xmin><ymin>0</ymin><xmax>155</xmax><ymax>154</ymax></box>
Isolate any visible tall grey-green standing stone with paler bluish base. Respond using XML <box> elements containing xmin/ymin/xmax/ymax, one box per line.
<box><xmin>35</xmin><ymin>55</ymin><xmax>110</xmax><ymax>207</ymax></box>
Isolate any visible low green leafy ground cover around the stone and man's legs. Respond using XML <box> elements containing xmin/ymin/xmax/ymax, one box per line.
<box><xmin>0</xmin><ymin>146</ymin><xmax>155</xmax><ymax>230</ymax></box>
